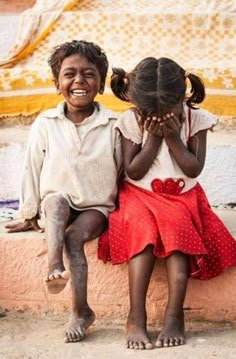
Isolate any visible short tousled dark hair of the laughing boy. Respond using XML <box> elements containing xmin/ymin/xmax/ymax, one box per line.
<box><xmin>48</xmin><ymin>40</ymin><xmax>109</xmax><ymax>93</ymax></box>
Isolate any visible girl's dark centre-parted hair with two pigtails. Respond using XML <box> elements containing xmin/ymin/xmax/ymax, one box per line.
<box><xmin>111</xmin><ymin>57</ymin><xmax>205</xmax><ymax>116</ymax></box>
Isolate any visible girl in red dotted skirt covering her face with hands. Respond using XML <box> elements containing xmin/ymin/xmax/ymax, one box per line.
<box><xmin>98</xmin><ymin>57</ymin><xmax>236</xmax><ymax>349</ymax></box>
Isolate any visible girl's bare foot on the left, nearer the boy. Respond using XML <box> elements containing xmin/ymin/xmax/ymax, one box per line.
<box><xmin>126</xmin><ymin>314</ymin><xmax>153</xmax><ymax>349</ymax></box>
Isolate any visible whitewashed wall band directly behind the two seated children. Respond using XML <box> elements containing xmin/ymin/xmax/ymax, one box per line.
<box><xmin>0</xmin><ymin>126</ymin><xmax>236</xmax><ymax>206</ymax></box>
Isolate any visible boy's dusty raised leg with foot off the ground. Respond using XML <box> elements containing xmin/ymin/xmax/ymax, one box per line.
<box><xmin>45</xmin><ymin>195</ymin><xmax>70</xmax><ymax>294</ymax></box>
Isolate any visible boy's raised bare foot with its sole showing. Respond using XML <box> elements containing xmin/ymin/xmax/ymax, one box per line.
<box><xmin>45</xmin><ymin>269</ymin><xmax>69</xmax><ymax>294</ymax></box>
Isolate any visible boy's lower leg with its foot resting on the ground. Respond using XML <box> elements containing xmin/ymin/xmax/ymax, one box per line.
<box><xmin>64</xmin><ymin>210</ymin><xmax>107</xmax><ymax>343</ymax></box>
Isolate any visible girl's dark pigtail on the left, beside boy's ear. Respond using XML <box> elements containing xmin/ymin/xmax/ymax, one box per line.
<box><xmin>111</xmin><ymin>68</ymin><xmax>130</xmax><ymax>102</ymax></box>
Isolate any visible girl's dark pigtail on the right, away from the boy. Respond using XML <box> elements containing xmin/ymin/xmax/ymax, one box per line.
<box><xmin>185</xmin><ymin>73</ymin><xmax>205</xmax><ymax>108</ymax></box>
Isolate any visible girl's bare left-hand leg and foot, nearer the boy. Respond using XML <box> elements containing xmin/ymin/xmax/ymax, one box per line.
<box><xmin>126</xmin><ymin>246</ymin><xmax>155</xmax><ymax>349</ymax></box>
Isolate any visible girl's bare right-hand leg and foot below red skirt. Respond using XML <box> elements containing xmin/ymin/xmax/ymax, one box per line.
<box><xmin>156</xmin><ymin>252</ymin><xmax>189</xmax><ymax>348</ymax></box>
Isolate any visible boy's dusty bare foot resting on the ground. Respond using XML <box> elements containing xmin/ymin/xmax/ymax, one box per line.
<box><xmin>64</xmin><ymin>309</ymin><xmax>95</xmax><ymax>343</ymax></box>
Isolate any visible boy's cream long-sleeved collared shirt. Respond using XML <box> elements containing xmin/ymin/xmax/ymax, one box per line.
<box><xmin>19</xmin><ymin>102</ymin><xmax>121</xmax><ymax>219</ymax></box>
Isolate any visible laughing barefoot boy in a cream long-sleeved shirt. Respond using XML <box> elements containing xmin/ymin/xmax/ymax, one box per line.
<box><xmin>7</xmin><ymin>41</ymin><xmax>121</xmax><ymax>342</ymax></box>
